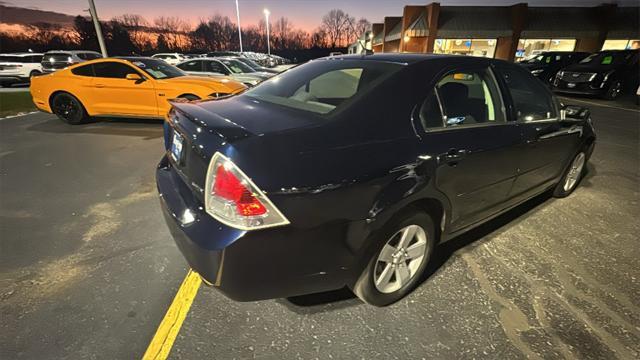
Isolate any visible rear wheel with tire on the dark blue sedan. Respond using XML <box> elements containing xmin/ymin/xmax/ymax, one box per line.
<box><xmin>352</xmin><ymin>208</ymin><xmax>436</xmax><ymax>306</ymax></box>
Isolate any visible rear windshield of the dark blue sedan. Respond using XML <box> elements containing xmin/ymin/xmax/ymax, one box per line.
<box><xmin>245</xmin><ymin>60</ymin><xmax>402</xmax><ymax>114</ymax></box>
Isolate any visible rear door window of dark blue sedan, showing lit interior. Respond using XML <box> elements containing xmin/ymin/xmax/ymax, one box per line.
<box><xmin>420</xmin><ymin>69</ymin><xmax>505</xmax><ymax>129</ymax></box>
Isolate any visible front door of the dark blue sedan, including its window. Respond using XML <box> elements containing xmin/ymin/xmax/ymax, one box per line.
<box><xmin>496</xmin><ymin>63</ymin><xmax>581</xmax><ymax>198</ymax></box>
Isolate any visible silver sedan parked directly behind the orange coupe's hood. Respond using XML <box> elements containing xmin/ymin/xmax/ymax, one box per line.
<box><xmin>176</xmin><ymin>58</ymin><xmax>274</xmax><ymax>86</ymax></box>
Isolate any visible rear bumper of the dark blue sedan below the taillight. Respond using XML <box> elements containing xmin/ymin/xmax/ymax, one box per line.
<box><xmin>156</xmin><ymin>156</ymin><xmax>353</xmax><ymax>301</ymax></box>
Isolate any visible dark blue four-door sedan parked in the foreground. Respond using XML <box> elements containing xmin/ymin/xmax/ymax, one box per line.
<box><xmin>156</xmin><ymin>54</ymin><xmax>595</xmax><ymax>306</ymax></box>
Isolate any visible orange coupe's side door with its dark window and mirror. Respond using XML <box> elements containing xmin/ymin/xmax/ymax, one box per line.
<box><xmin>91</xmin><ymin>61</ymin><xmax>158</xmax><ymax>116</ymax></box>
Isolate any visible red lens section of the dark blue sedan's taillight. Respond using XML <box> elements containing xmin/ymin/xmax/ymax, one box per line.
<box><xmin>211</xmin><ymin>164</ymin><xmax>267</xmax><ymax>216</ymax></box>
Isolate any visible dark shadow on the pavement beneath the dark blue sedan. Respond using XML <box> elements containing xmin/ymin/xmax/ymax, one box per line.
<box><xmin>276</xmin><ymin>180</ymin><xmax>576</xmax><ymax>314</ymax></box>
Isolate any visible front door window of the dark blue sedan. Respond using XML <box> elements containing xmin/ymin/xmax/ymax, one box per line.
<box><xmin>497</xmin><ymin>65</ymin><xmax>556</xmax><ymax>121</ymax></box>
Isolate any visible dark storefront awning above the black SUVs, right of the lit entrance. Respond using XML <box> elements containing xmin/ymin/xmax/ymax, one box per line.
<box><xmin>520</xmin><ymin>7</ymin><xmax>600</xmax><ymax>39</ymax></box>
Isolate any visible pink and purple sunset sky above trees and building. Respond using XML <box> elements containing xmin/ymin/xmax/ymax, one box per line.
<box><xmin>3</xmin><ymin>0</ymin><xmax>636</xmax><ymax>31</ymax></box>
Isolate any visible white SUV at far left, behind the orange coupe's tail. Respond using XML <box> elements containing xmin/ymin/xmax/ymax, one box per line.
<box><xmin>0</xmin><ymin>53</ymin><xmax>42</xmax><ymax>85</ymax></box>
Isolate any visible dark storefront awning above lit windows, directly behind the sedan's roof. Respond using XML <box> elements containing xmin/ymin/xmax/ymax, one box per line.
<box><xmin>438</xmin><ymin>6</ymin><xmax>512</xmax><ymax>39</ymax></box>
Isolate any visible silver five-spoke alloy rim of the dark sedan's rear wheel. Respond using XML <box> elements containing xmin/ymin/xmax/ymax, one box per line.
<box><xmin>373</xmin><ymin>225</ymin><xmax>428</xmax><ymax>294</ymax></box>
